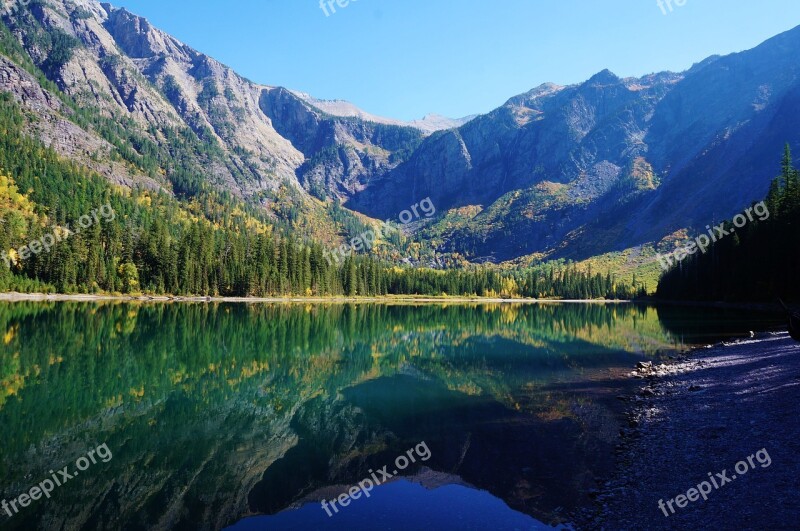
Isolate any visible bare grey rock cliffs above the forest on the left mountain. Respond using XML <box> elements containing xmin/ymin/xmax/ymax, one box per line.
<box><xmin>5</xmin><ymin>0</ymin><xmax>432</xmax><ymax>206</ymax></box>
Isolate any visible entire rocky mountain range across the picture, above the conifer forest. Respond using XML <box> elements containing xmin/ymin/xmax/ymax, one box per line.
<box><xmin>0</xmin><ymin>0</ymin><xmax>800</xmax><ymax>263</ymax></box>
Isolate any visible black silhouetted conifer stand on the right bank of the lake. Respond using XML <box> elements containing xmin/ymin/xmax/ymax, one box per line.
<box><xmin>658</xmin><ymin>145</ymin><xmax>800</xmax><ymax>302</ymax></box>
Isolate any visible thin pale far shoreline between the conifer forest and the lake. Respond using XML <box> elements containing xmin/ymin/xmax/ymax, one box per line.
<box><xmin>0</xmin><ymin>292</ymin><xmax>636</xmax><ymax>304</ymax></box>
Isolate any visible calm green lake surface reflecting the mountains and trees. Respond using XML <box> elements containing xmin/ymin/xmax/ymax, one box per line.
<box><xmin>0</xmin><ymin>302</ymin><xmax>776</xmax><ymax>530</ymax></box>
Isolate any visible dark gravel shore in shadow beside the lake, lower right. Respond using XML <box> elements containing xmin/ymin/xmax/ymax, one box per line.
<box><xmin>592</xmin><ymin>333</ymin><xmax>800</xmax><ymax>531</ymax></box>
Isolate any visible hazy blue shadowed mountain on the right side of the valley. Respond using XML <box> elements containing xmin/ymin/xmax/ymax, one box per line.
<box><xmin>347</xmin><ymin>28</ymin><xmax>800</xmax><ymax>260</ymax></box>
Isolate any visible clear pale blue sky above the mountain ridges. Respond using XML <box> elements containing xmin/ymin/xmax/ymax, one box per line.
<box><xmin>112</xmin><ymin>0</ymin><xmax>800</xmax><ymax>119</ymax></box>
